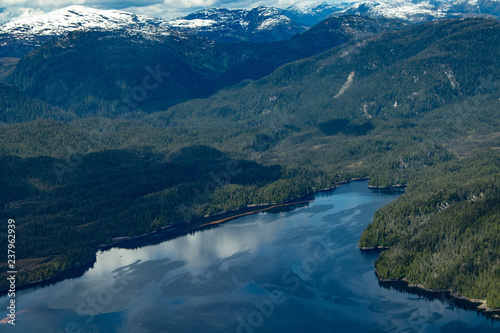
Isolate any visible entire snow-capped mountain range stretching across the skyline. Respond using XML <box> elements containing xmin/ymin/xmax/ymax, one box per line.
<box><xmin>0</xmin><ymin>0</ymin><xmax>500</xmax><ymax>58</ymax></box>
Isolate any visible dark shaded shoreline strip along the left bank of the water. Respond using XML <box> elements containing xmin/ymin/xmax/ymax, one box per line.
<box><xmin>0</xmin><ymin>177</ymin><xmax>378</xmax><ymax>297</ymax></box>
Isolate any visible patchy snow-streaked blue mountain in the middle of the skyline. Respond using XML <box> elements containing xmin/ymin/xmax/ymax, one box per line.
<box><xmin>169</xmin><ymin>6</ymin><xmax>306</xmax><ymax>42</ymax></box>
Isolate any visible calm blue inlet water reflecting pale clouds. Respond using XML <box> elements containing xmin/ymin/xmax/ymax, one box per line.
<box><xmin>0</xmin><ymin>182</ymin><xmax>500</xmax><ymax>333</ymax></box>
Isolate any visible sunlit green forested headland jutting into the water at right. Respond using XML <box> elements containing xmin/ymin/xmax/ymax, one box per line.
<box><xmin>360</xmin><ymin>152</ymin><xmax>500</xmax><ymax>308</ymax></box>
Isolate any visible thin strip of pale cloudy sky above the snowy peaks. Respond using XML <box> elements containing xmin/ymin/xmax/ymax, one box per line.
<box><xmin>0</xmin><ymin>0</ymin><xmax>333</xmax><ymax>24</ymax></box>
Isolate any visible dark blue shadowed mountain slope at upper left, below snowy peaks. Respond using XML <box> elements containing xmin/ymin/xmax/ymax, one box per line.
<box><xmin>6</xmin><ymin>17</ymin><xmax>402</xmax><ymax>116</ymax></box>
